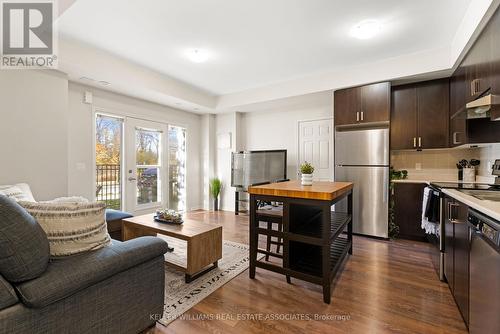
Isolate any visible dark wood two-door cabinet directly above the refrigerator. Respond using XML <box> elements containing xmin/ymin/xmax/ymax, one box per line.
<box><xmin>334</xmin><ymin>82</ymin><xmax>391</xmax><ymax>126</ymax></box>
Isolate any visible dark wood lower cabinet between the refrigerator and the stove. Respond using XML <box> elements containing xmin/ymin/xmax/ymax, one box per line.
<box><xmin>393</xmin><ymin>182</ymin><xmax>427</xmax><ymax>241</ymax></box>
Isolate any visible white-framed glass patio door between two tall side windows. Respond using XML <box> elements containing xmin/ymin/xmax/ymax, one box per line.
<box><xmin>125</xmin><ymin>118</ymin><xmax>168</xmax><ymax>214</ymax></box>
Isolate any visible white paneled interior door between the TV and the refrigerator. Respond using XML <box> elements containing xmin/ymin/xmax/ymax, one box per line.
<box><xmin>298</xmin><ymin>119</ymin><xmax>333</xmax><ymax>181</ymax></box>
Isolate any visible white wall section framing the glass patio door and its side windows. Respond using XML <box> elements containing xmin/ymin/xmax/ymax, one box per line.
<box><xmin>68</xmin><ymin>83</ymin><xmax>203</xmax><ymax>210</ymax></box>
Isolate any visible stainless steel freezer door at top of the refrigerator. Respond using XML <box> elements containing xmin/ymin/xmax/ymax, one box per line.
<box><xmin>335</xmin><ymin>129</ymin><xmax>389</xmax><ymax>166</ymax></box>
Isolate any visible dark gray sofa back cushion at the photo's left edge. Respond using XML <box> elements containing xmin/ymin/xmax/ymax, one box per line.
<box><xmin>0</xmin><ymin>195</ymin><xmax>49</xmax><ymax>282</ymax></box>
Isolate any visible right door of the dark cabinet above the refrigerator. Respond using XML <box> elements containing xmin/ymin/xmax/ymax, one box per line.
<box><xmin>360</xmin><ymin>82</ymin><xmax>391</xmax><ymax>123</ymax></box>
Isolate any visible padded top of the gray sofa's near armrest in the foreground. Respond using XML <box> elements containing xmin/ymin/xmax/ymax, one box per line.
<box><xmin>15</xmin><ymin>237</ymin><xmax>168</xmax><ymax>308</ymax></box>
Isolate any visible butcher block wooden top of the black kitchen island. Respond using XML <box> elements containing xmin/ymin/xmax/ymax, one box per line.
<box><xmin>248</xmin><ymin>180</ymin><xmax>353</xmax><ymax>201</ymax></box>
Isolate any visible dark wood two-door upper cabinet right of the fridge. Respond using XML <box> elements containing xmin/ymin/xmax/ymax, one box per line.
<box><xmin>391</xmin><ymin>79</ymin><xmax>450</xmax><ymax>150</ymax></box>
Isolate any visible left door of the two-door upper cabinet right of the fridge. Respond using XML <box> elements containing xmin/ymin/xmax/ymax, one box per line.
<box><xmin>391</xmin><ymin>85</ymin><xmax>417</xmax><ymax>150</ymax></box>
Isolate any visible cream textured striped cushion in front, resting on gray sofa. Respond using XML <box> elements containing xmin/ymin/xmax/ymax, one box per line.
<box><xmin>19</xmin><ymin>202</ymin><xmax>111</xmax><ymax>257</ymax></box>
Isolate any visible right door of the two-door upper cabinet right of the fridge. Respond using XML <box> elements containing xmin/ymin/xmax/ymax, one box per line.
<box><xmin>417</xmin><ymin>79</ymin><xmax>450</xmax><ymax>148</ymax></box>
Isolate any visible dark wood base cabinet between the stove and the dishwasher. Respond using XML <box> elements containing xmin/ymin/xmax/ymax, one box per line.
<box><xmin>444</xmin><ymin>197</ymin><xmax>470</xmax><ymax>325</ymax></box>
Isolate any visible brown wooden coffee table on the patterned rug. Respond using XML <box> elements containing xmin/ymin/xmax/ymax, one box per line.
<box><xmin>122</xmin><ymin>214</ymin><xmax>222</xmax><ymax>283</ymax></box>
